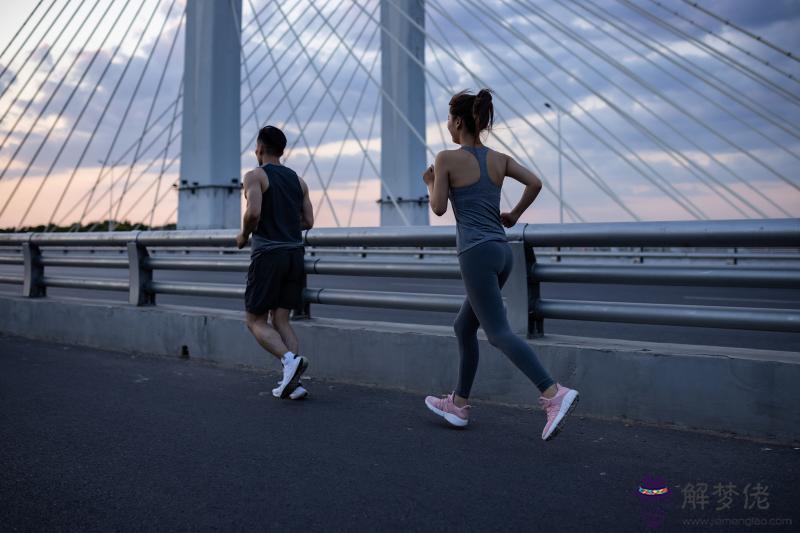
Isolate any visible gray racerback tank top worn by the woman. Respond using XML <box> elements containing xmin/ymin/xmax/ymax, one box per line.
<box><xmin>450</xmin><ymin>146</ymin><xmax>506</xmax><ymax>255</ymax></box>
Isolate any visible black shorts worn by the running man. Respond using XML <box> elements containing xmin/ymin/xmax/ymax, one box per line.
<box><xmin>244</xmin><ymin>248</ymin><xmax>305</xmax><ymax>315</ymax></box>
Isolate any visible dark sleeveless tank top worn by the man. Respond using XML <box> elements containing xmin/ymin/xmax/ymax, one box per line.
<box><xmin>250</xmin><ymin>163</ymin><xmax>303</xmax><ymax>257</ymax></box>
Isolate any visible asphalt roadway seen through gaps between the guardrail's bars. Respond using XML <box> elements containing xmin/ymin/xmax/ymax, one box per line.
<box><xmin>0</xmin><ymin>258</ymin><xmax>800</xmax><ymax>351</ymax></box>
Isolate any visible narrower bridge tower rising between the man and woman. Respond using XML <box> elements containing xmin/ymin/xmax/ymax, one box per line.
<box><xmin>379</xmin><ymin>0</ymin><xmax>429</xmax><ymax>226</ymax></box>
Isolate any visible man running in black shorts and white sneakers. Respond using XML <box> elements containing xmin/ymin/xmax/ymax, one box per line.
<box><xmin>236</xmin><ymin>126</ymin><xmax>314</xmax><ymax>399</ymax></box>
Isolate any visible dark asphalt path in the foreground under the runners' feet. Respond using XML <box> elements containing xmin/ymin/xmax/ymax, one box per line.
<box><xmin>0</xmin><ymin>336</ymin><xmax>800</xmax><ymax>533</ymax></box>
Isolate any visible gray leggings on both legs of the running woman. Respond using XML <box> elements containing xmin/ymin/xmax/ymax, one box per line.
<box><xmin>453</xmin><ymin>241</ymin><xmax>555</xmax><ymax>398</ymax></box>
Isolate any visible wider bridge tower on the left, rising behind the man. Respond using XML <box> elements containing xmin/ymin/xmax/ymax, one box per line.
<box><xmin>178</xmin><ymin>0</ymin><xmax>242</xmax><ymax>229</ymax></box>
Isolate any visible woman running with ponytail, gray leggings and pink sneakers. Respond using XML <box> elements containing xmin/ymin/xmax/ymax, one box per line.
<box><xmin>422</xmin><ymin>89</ymin><xmax>578</xmax><ymax>440</ymax></box>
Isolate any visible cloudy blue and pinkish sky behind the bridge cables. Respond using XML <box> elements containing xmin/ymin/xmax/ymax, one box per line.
<box><xmin>0</xmin><ymin>0</ymin><xmax>800</xmax><ymax>227</ymax></box>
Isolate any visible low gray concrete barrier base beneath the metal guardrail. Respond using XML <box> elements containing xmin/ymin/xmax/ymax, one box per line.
<box><xmin>0</xmin><ymin>296</ymin><xmax>800</xmax><ymax>443</ymax></box>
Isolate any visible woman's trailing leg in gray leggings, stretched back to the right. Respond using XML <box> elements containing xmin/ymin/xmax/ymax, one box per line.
<box><xmin>459</xmin><ymin>242</ymin><xmax>555</xmax><ymax>392</ymax></box>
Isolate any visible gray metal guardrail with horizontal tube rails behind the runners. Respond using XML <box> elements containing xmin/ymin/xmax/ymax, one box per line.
<box><xmin>0</xmin><ymin>219</ymin><xmax>800</xmax><ymax>335</ymax></box>
